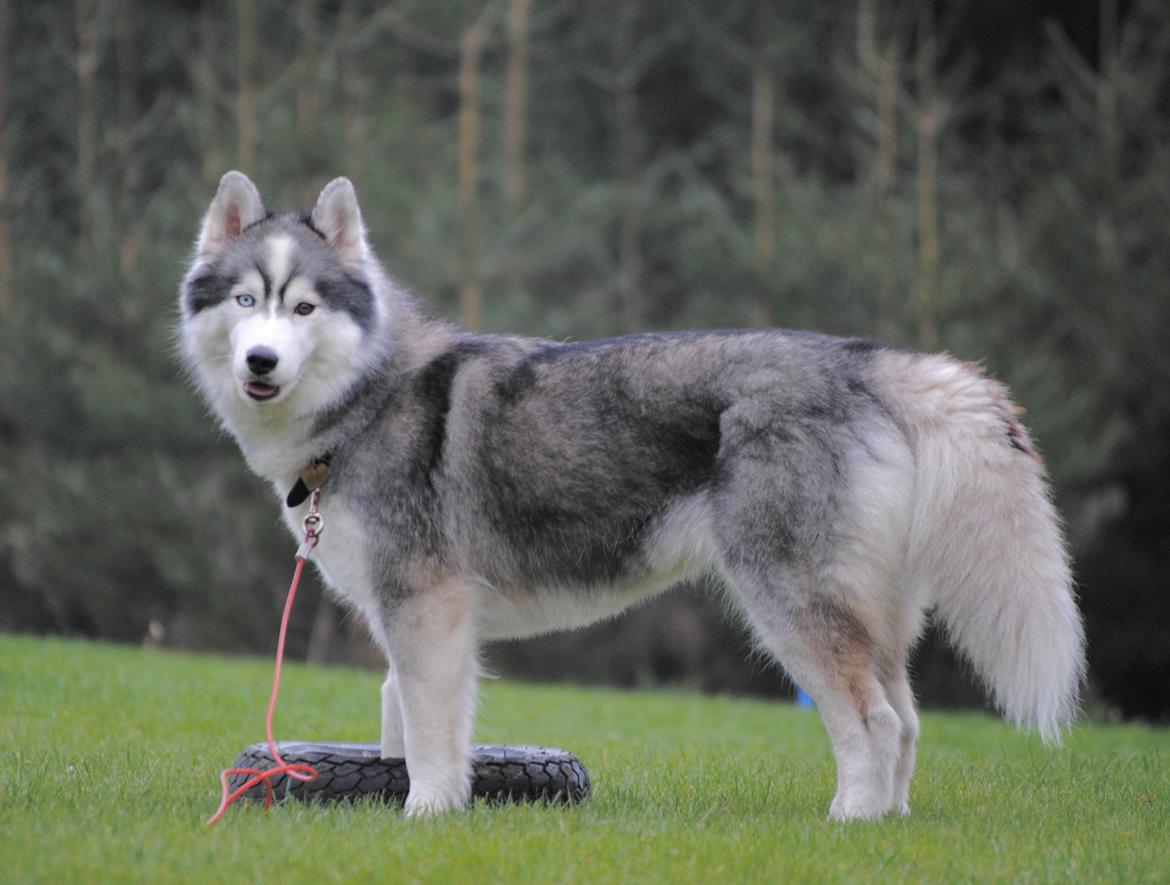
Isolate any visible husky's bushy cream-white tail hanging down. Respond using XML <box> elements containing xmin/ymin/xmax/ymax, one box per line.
<box><xmin>879</xmin><ymin>352</ymin><xmax>1085</xmax><ymax>743</ymax></box>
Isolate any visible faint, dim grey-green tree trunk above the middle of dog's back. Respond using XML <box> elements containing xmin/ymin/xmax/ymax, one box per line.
<box><xmin>613</xmin><ymin>2</ymin><xmax>644</xmax><ymax>331</ymax></box>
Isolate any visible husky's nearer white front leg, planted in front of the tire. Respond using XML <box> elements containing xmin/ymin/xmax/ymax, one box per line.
<box><xmin>383</xmin><ymin>582</ymin><xmax>479</xmax><ymax>817</ymax></box>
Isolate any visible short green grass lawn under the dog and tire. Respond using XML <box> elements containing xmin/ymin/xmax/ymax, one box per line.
<box><xmin>0</xmin><ymin>636</ymin><xmax>1170</xmax><ymax>883</ymax></box>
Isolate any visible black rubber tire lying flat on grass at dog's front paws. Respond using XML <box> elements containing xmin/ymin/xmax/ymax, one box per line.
<box><xmin>228</xmin><ymin>742</ymin><xmax>590</xmax><ymax>804</ymax></box>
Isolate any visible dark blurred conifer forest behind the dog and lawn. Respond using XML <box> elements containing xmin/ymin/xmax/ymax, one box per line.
<box><xmin>0</xmin><ymin>0</ymin><xmax>1170</xmax><ymax>720</ymax></box>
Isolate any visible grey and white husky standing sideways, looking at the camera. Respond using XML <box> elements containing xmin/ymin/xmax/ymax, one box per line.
<box><xmin>179</xmin><ymin>172</ymin><xmax>1085</xmax><ymax>821</ymax></box>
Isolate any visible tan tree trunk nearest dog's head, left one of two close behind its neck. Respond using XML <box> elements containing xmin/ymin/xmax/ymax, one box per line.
<box><xmin>459</xmin><ymin>14</ymin><xmax>483</xmax><ymax>329</ymax></box>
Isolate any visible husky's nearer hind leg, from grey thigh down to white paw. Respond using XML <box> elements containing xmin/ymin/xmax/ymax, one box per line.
<box><xmin>713</xmin><ymin>398</ymin><xmax>914</xmax><ymax>821</ymax></box>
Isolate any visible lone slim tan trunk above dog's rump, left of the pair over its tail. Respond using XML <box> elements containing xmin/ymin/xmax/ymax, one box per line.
<box><xmin>751</xmin><ymin>4</ymin><xmax>776</xmax><ymax>325</ymax></box>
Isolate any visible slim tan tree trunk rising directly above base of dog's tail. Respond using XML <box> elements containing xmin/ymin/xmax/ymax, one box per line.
<box><xmin>916</xmin><ymin>0</ymin><xmax>941</xmax><ymax>350</ymax></box>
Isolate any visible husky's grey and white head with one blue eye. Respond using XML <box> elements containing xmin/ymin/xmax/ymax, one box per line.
<box><xmin>180</xmin><ymin>172</ymin><xmax>384</xmax><ymax>414</ymax></box>
